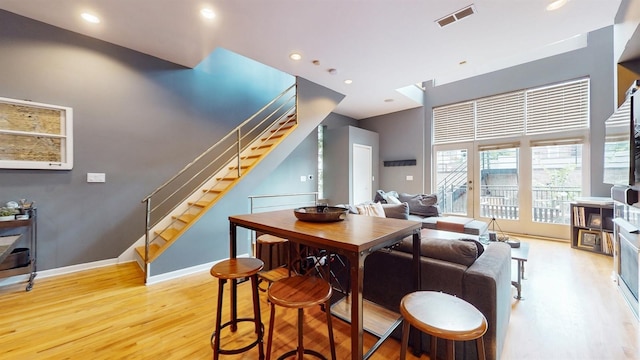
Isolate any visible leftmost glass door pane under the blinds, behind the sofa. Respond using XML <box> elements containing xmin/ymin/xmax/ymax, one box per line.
<box><xmin>435</xmin><ymin>149</ymin><xmax>473</xmax><ymax>216</ymax></box>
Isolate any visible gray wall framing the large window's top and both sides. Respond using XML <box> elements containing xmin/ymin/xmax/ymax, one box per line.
<box><xmin>359</xmin><ymin>27</ymin><xmax>615</xmax><ymax>196</ymax></box>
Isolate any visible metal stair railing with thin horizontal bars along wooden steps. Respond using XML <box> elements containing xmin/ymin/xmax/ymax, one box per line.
<box><xmin>142</xmin><ymin>83</ymin><xmax>297</xmax><ymax>265</ymax></box>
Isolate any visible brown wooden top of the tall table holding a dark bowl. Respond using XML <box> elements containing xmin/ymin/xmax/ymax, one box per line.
<box><xmin>229</xmin><ymin>210</ymin><xmax>422</xmax><ymax>252</ymax></box>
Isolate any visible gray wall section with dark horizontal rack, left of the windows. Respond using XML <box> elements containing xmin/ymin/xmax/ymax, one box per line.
<box><xmin>359</xmin><ymin>107</ymin><xmax>424</xmax><ymax>194</ymax></box>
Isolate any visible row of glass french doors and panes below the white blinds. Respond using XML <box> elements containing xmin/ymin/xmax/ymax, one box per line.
<box><xmin>433</xmin><ymin>141</ymin><xmax>585</xmax><ymax>238</ymax></box>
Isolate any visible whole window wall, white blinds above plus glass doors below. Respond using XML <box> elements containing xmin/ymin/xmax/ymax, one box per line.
<box><xmin>432</xmin><ymin>78</ymin><xmax>590</xmax><ymax>233</ymax></box>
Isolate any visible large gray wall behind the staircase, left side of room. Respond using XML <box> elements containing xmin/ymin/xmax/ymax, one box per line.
<box><xmin>0</xmin><ymin>10</ymin><xmax>294</xmax><ymax>270</ymax></box>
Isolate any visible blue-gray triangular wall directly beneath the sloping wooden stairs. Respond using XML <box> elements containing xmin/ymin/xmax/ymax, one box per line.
<box><xmin>150</xmin><ymin>78</ymin><xmax>344</xmax><ymax>276</ymax></box>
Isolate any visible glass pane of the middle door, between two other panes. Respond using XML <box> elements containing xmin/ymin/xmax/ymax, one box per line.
<box><xmin>479</xmin><ymin>148</ymin><xmax>520</xmax><ymax>220</ymax></box>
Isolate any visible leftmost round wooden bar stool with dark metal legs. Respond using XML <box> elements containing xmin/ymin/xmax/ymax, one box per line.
<box><xmin>210</xmin><ymin>258</ymin><xmax>264</xmax><ymax>360</ymax></box>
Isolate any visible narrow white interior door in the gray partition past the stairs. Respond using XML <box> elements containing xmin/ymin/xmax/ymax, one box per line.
<box><xmin>351</xmin><ymin>144</ymin><xmax>373</xmax><ymax>204</ymax></box>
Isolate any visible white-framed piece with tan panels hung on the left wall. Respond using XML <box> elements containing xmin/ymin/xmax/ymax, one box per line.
<box><xmin>0</xmin><ymin>97</ymin><xmax>73</xmax><ymax>170</ymax></box>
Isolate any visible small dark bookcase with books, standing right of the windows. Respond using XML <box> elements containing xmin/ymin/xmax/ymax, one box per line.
<box><xmin>571</xmin><ymin>202</ymin><xmax>615</xmax><ymax>256</ymax></box>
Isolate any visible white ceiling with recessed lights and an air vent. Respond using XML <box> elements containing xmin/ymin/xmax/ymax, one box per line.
<box><xmin>0</xmin><ymin>0</ymin><xmax>620</xmax><ymax>119</ymax></box>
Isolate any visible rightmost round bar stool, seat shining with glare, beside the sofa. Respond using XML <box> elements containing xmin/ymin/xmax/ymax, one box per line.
<box><xmin>400</xmin><ymin>291</ymin><xmax>487</xmax><ymax>360</ymax></box>
